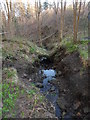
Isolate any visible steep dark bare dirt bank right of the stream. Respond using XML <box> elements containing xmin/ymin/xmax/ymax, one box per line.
<box><xmin>51</xmin><ymin>48</ymin><xmax>90</xmax><ymax>118</ymax></box>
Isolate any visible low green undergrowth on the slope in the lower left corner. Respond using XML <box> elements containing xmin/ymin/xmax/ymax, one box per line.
<box><xmin>0</xmin><ymin>68</ymin><xmax>45</xmax><ymax>118</ymax></box>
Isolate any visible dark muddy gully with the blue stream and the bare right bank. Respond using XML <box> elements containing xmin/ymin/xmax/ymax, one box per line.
<box><xmin>31</xmin><ymin>52</ymin><xmax>89</xmax><ymax>120</ymax></box>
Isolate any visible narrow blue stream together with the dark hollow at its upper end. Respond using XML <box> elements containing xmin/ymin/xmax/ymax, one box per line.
<box><xmin>39</xmin><ymin>57</ymin><xmax>61</xmax><ymax>118</ymax></box>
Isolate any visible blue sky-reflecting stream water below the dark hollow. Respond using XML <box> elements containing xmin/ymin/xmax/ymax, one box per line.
<box><xmin>39</xmin><ymin>69</ymin><xmax>61</xmax><ymax>118</ymax></box>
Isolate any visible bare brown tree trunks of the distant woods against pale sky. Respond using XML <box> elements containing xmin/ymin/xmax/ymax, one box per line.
<box><xmin>0</xmin><ymin>0</ymin><xmax>86</xmax><ymax>46</ymax></box>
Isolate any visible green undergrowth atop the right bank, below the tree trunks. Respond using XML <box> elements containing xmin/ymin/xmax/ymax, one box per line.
<box><xmin>61</xmin><ymin>39</ymin><xmax>88</xmax><ymax>60</ymax></box>
